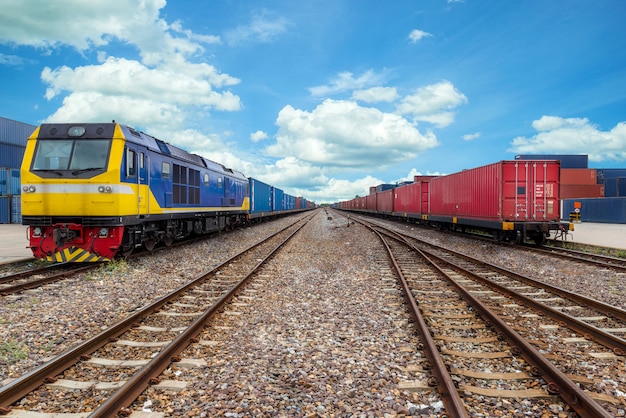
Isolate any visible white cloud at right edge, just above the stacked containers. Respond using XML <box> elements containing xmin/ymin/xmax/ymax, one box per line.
<box><xmin>510</xmin><ymin>116</ymin><xmax>626</xmax><ymax>161</ymax></box>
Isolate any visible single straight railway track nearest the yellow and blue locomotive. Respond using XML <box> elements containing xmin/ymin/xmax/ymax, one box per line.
<box><xmin>0</xmin><ymin>214</ymin><xmax>310</xmax><ymax>417</ymax></box>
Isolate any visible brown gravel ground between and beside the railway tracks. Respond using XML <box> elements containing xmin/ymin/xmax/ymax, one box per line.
<box><xmin>0</xmin><ymin>210</ymin><xmax>626</xmax><ymax>417</ymax></box>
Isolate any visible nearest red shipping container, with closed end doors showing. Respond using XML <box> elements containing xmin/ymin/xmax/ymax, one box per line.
<box><xmin>429</xmin><ymin>160</ymin><xmax>560</xmax><ymax>221</ymax></box>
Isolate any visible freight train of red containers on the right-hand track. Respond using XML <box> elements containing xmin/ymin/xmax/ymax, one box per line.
<box><xmin>334</xmin><ymin>160</ymin><xmax>574</xmax><ymax>245</ymax></box>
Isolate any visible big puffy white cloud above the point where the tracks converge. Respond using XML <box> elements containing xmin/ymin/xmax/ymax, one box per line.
<box><xmin>266</xmin><ymin>99</ymin><xmax>437</xmax><ymax>169</ymax></box>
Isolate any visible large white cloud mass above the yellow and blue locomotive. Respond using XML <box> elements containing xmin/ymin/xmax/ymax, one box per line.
<box><xmin>0</xmin><ymin>0</ymin><xmax>241</xmax><ymax>130</ymax></box>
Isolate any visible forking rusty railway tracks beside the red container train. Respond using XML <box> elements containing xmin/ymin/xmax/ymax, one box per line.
<box><xmin>354</xmin><ymin>217</ymin><xmax>626</xmax><ymax>417</ymax></box>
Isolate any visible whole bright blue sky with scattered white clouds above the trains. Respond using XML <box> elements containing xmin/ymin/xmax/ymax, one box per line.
<box><xmin>0</xmin><ymin>0</ymin><xmax>626</xmax><ymax>203</ymax></box>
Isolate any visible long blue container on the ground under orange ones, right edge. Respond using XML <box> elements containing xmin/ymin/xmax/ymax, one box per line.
<box><xmin>562</xmin><ymin>197</ymin><xmax>626</xmax><ymax>224</ymax></box>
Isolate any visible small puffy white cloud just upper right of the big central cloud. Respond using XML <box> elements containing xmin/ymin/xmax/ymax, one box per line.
<box><xmin>397</xmin><ymin>80</ymin><xmax>467</xmax><ymax>127</ymax></box>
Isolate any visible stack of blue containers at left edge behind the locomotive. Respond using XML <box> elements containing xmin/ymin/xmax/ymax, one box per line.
<box><xmin>0</xmin><ymin>117</ymin><xmax>36</xmax><ymax>224</ymax></box>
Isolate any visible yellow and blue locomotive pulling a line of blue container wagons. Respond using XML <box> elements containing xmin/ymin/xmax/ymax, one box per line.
<box><xmin>21</xmin><ymin>122</ymin><xmax>315</xmax><ymax>262</ymax></box>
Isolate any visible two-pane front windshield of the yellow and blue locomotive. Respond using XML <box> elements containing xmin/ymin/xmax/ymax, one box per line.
<box><xmin>32</xmin><ymin>139</ymin><xmax>111</xmax><ymax>176</ymax></box>
